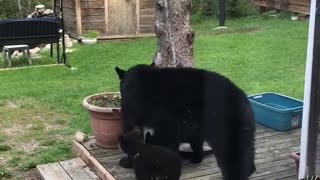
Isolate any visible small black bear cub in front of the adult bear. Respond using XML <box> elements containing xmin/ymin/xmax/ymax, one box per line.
<box><xmin>119</xmin><ymin>131</ymin><xmax>182</xmax><ymax>180</ymax></box>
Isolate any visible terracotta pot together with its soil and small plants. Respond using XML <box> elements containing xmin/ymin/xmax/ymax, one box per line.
<box><xmin>82</xmin><ymin>92</ymin><xmax>122</xmax><ymax>148</ymax></box>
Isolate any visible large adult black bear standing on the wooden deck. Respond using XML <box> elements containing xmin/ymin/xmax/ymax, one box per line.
<box><xmin>116</xmin><ymin>65</ymin><xmax>255</xmax><ymax>180</ymax></box>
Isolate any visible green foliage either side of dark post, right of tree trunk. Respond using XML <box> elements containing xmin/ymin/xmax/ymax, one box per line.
<box><xmin>192</xmin><ymin>0</ymin><xmax>256</xmax><ymax>18</ymax></box>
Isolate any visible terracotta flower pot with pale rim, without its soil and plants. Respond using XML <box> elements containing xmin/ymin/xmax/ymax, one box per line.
<box><xmin>82</xmin><ymin>92</ymin><xmax>122</xmax><ymax>148</ymax></box>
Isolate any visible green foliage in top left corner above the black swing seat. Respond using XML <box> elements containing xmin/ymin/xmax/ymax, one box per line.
<box><xmin>0</xmin><ymin>0</ymin><xmax>52</xmax><ymax>19</ymax></box>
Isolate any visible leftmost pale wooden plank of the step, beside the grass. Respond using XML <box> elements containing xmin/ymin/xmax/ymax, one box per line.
<box><xmin>37</xmin><ymin>162</ymin><xmax>71</xmax><ymax>180</ymax></box>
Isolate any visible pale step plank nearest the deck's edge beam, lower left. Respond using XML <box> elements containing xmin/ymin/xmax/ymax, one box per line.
<box><xmin>59</xmin><ymin>158</ymin><xmax>99</xmax><ymax>180</ymax></box>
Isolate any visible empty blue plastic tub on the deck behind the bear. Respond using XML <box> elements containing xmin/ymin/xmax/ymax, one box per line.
<box><xmin>248</xmin><ymin>92</ymin><xmax>303</xmax><ymax>131</ymax></box>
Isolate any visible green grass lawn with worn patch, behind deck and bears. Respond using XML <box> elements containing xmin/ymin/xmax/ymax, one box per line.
<box><xmin>0</xmin><ymin>17</ymin><xmax>308</xmax><ymax>179</ymax></box>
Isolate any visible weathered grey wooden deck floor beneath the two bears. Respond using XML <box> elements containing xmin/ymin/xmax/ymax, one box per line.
<box><xmin>73</xmin><ymin>125</ymin><xmax>300</xmax><ymax>180</ymax></box>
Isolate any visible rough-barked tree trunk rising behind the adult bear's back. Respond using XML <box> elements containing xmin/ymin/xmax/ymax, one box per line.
<box><xmin>153</xmin><ymin>0</ymin><xmax>195</xmax><ymax>67</ymax></box>
